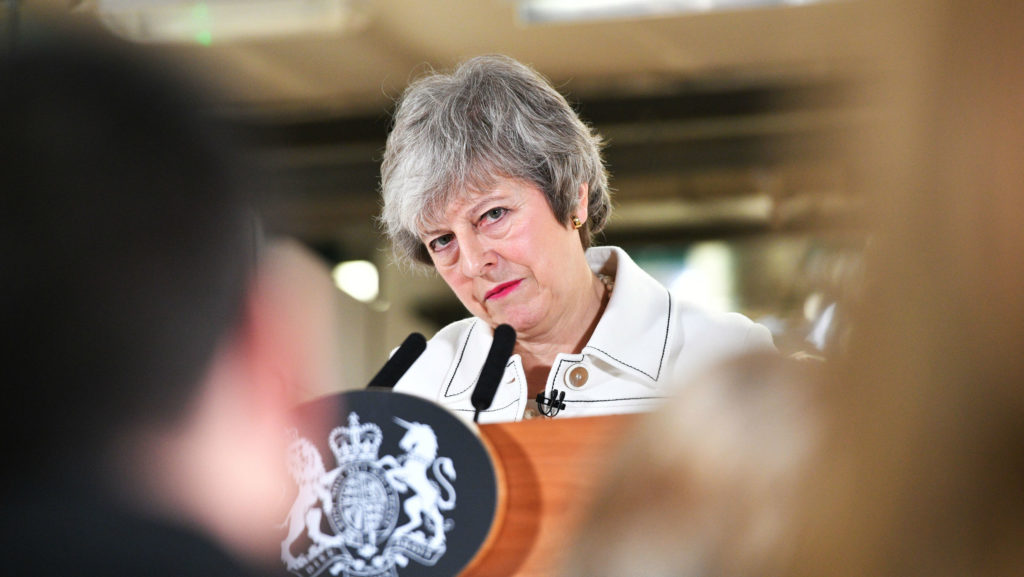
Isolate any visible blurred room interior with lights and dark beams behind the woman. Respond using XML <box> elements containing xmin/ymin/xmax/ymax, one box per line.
<box><xmin>0</xmin><ymin>0</ymin><xmax>880</xmax><ymax>387</ymax></box>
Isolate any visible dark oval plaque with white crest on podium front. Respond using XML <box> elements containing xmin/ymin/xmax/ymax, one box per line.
<box><xmin>281</xmin><ymin>390</ymin><xmax>498</xmax><ymax>577</ymax></box>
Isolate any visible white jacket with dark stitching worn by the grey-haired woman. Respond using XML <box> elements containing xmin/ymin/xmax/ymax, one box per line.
<box><xmin>395</xmin><ymin>246</ymin><xmax>774</xmax><ymax>423</ymax></box>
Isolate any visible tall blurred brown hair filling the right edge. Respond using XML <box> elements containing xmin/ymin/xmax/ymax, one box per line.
<box><xmin>791</xmin><ymin>0</ymin><xmax>1024</xmax><ymax>576</ymax></box>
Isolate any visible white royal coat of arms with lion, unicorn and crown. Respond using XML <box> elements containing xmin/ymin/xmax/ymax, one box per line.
<box><xmin>281</xmin><ymin>412</ymin><xmax>456</xmax><ymax>577</ymax></box>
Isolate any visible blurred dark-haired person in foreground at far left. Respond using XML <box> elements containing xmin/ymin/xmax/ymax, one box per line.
<box><xmin>0</xmin><ymin>30</ymin><xmax>307</xmax><ymax>577</ymax></box>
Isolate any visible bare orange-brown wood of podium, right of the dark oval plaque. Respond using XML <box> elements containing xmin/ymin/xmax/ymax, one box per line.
<box><xmin>460</xmin><ymin>415</ymin><xmax>637</xmax><ymax>577</ymax></box>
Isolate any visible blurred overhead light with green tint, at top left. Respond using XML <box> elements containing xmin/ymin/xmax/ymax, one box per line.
<box><xmin>97</xmin><ymin>0</ymin><xmax>368</xmax><ymax>45</ymax></box>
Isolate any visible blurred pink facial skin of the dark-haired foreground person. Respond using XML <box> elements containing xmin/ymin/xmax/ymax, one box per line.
<box><xmin>161</xmin><ymin>244</ymin><xmax>335</xmax><ymax>567</ymax></box>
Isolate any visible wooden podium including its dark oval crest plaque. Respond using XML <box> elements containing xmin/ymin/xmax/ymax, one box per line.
<box><xmin>281</xmin><ymin>390</ymin><xmax>637</xmax><ymax>577</ymax></box>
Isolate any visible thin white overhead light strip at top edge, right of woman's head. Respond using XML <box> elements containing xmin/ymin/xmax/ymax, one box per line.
<box><xmin>518</xmin><ymin>0</ymin><xmax>831</xmax><ymax>24</ymax></box>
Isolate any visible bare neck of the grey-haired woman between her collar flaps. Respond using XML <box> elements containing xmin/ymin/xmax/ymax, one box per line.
<box><xmin>515</xmin><ymin>269</ymin><xmax>611</xmax><ymax>399</ymax></box>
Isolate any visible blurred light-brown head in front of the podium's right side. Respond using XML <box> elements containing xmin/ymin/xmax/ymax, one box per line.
<box><xmin>560</xmin><ymin>355</ymin><xmax>822</xmax><ymax>577</ymax></box>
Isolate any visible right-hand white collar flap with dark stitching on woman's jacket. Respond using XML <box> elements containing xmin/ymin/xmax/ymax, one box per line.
<box><xmin>583</xmin><ymin>246</ymin><xmax>674</xmax><ymax>384</ymax></box>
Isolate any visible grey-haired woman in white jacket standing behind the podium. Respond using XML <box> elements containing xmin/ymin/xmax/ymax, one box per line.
<box><xmin>382</xmin><ymin>56</ymin><xmax>773</xmax><ymax>422</ymax></box>
